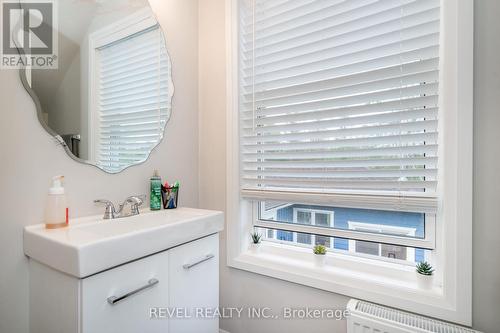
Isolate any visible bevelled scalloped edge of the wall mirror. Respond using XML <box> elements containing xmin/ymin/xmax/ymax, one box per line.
<box><xmin>16</xmin><ymin>5</ymin><xmax>175</xmax><ymax>175</ymax></box>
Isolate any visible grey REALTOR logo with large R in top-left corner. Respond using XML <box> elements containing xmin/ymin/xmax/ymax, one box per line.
<box><xmin>1</xmin><ymin>0</ymin><xmax>58</xmax><ymax>69</ymax></box>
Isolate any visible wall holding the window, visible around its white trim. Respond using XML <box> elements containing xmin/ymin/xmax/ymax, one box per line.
<box><xmin>199</xmin><ymin>0</ymin><xmax>500</xmax><ymax>333</ymax></box>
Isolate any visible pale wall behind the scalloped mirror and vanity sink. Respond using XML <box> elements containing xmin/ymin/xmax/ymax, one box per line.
<box><xmin>0</xmin><ymin>0</ymin><xmax>198</xmax><ymax>333</ymax></box>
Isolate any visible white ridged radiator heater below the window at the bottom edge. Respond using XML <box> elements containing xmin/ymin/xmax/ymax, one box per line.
<box><xmin>347</xmin><ymin>299</ymin><xmax>481</xmax><ymax>333</ymax></box>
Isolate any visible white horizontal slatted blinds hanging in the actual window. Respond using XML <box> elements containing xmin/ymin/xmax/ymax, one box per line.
<box><xmin>239</xmin><ymin>0</ymin><xmax>440</xmax><ymax>211</ymax></box>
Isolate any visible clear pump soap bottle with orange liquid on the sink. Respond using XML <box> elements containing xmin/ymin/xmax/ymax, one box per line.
<box><xmin>45</xmin><ymin>176</ymin><xmax>68</xmax><ymax>229</ymax></box>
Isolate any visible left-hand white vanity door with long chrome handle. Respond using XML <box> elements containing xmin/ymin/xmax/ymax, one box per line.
<box><xmin>81</xmin><ymin>249</ymin><xmax>169</xmax><ymax>333</ymax></box>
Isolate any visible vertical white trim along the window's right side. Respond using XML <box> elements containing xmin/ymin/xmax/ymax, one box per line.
<box><xmin>435</xmin><ymin>0</ymin><xmax>474</xmax><ymax>325</ymax></box>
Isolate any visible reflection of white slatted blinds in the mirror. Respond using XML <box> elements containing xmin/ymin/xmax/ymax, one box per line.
<box><xmin>97</xmin><ymin>26</ymin><xmax>170</xmax><ymax>171</ymax></box>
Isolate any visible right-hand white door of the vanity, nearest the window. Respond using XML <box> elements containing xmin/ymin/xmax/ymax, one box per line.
<box><xmin>169</xmin><ymin>235</ymin><xmax>219</xmax><ymax>333</ymax></box>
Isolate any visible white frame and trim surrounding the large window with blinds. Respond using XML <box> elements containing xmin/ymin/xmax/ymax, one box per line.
<box><xmin>226</xmin><ymin>0</ymin><xmax>474</xmax><ymax>326</ymax></box>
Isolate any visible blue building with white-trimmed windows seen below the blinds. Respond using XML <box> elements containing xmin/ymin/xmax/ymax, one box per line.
<box><xmin>259</xmin><ymin>201</ymin><xmax>426</xmax><ymax>262</ymax></box>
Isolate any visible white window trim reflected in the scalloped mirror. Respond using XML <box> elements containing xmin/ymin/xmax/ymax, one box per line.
<box><xmin>87</xmin><ymin>7</ymin><xmax>158</xmax><ymax>164</ymax></box>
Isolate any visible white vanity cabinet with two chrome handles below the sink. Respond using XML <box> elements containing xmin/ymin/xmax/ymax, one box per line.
<box><xmin>30</xmin><ymin>234</ymin><xmax>219</xmax><ymax>333</ymax></box>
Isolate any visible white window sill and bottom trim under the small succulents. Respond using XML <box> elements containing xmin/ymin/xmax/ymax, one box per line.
<box><xmin>230</xmin><ymin>242</ymin><xmax>456</xmax><ymax>320</ymax></box>
